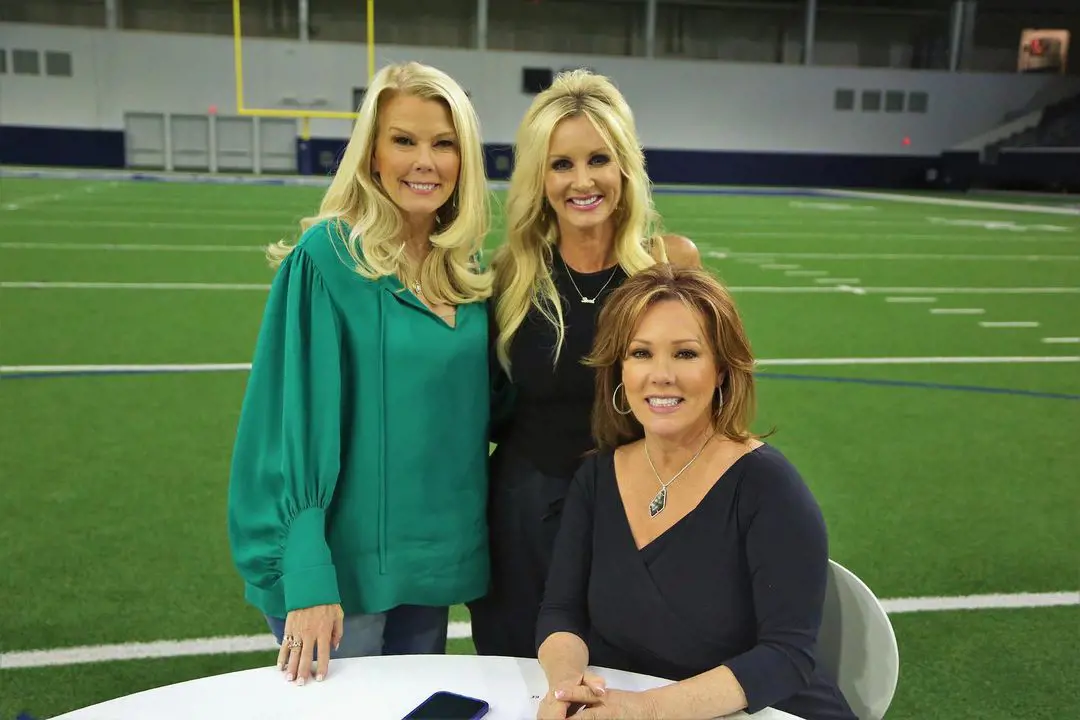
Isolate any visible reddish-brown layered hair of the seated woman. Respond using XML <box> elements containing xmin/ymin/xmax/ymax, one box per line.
<box><xmin>585</xmin><ymin>263</ymin><xmax>771</xmax><ymax>450</ymax></box>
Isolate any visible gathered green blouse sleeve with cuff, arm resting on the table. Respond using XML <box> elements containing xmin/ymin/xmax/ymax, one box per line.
<box><xmin>228</xmin><ymin>245</ymin><xmax>342</xmax><ymax>614</ymax></box>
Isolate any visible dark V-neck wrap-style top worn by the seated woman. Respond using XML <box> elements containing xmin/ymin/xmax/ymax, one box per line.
<box><xmin>537</xmin><ymin>444</ymin><xmax>855</xmax><ymax>720</ymax></box>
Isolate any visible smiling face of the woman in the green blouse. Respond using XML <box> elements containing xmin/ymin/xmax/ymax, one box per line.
<box><xmin>372</xmin><ymin>94</ymin><xmax>461</xmax><ymax>223</ymax></box>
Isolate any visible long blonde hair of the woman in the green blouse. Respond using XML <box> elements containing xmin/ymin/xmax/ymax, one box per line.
<box><xmin>267</xmin><ymin>63</ymin><xmax>492</xmax><ymax>304</ymax></box>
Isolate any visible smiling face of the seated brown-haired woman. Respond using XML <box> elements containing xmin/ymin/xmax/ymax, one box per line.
<box><xmin>622</xmin><ymin>300</ymin><xmax>719</xmax><ymax>438</ymax></box>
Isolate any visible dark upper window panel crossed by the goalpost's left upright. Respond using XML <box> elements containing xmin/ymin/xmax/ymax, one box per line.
<box><xmin>118</xmin><ymin>0</ymin><xmax>300</xmax><ymax>38</ymax></box>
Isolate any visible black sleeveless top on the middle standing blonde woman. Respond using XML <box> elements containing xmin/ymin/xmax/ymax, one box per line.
<box><xmin>497</xmin><ymin>250</ymin><xmax>626</xmax><ymax>477</ymax></box>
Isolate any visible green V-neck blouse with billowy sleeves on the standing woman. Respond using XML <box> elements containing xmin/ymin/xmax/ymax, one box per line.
<box><xmin>229</xmin><ymin>221</ymin><xmax>490</xmax><ymax>617</ymax></box>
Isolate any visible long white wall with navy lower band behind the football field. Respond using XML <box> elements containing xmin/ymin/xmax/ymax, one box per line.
<box><xmin>0</xmin><ymin>24</ymin><xmax>1080</xmax><ymax>187</ymax></box>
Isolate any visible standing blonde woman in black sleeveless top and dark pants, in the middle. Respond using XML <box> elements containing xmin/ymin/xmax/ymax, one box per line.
<box><xmin>469</xmin><ymin>70</ymin><xmax>700</xmax><ymax>657</ymax></box>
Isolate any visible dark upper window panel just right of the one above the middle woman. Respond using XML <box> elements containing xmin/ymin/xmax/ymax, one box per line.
<box><xmin>657</xmin><ymin>0</ymin><xmax>806</xmax><ymax>63</ymax></box>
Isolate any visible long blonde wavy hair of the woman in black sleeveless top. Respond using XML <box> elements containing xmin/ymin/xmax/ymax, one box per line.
<box><xmin>491</xmin><ymin>70</ymin><xmax>667</xmax><ymax>373</ymax></box>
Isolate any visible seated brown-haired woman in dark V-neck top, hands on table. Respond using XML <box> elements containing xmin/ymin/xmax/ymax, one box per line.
<box><xmin>537</xmin><ymin>264</ymin><xmax>854</xmax><ymax>720</ymax></box>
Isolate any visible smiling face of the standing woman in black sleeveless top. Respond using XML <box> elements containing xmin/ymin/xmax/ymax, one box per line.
<box><xmin>544</xmin><ymin>116</ymin><xmax>622</xmax><ymax>232</ymax></box>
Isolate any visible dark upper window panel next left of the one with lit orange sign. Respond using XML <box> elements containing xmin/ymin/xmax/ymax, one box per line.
<box><xmin>814</xmin><ymin>0</ymin><xmax>950</xmax><ymax>69</ymax></box>
